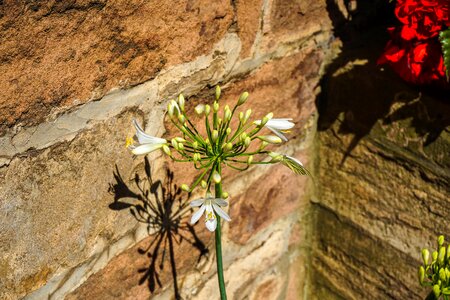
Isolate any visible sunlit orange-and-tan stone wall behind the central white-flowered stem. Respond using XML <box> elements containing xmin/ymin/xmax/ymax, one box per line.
<box><xmin>0</xmin><ymin>0</ymin><xmax>331</xmax><ymax>299</ymax></box>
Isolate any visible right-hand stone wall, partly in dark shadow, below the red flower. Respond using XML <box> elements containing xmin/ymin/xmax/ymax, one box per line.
<box><xmin>311</xmin><ymin>1</ymin><xmax>450</xmax><ymax>299</ymax></box>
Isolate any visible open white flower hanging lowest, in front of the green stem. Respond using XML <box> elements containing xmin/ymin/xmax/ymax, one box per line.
<box><xmin>190</xmin><ymin>198</ymin><xmax>231</xmax><ymax>232</ymax></box>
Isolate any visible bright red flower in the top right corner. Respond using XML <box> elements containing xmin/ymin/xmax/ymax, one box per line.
<box><xmin>395</xmin><ymin>0</ymin><xmax>450</xmax><ymax>40</ymax></box>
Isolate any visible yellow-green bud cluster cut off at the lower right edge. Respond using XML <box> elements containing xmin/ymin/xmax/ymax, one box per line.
<box><xmin>419</xmin><ymin>235</ymin><xmax>450</xmax><ymax>300</ymax></box>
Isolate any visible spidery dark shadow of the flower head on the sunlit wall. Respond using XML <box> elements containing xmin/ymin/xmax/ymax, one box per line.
<box><xmin>109</xmin><ymin>157</ymin><xmax>209</xmax><ymax>299</ymax></box>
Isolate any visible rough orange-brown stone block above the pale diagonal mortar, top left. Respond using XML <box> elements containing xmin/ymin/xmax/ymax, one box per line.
<box><xmin>0</xmin><ymin>0</ymin><xmax>233</xmax><ymax>133</ymax></box>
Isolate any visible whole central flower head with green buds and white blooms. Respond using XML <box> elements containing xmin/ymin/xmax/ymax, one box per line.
<box><xmin>127</xmin><ymin>86</ymin><xmax>308</xmax><ymax>230</ymax></box>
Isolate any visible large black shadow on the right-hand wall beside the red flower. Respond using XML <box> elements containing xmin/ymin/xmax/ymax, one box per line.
<box><xmin>316</xmin><ymin>0</ymin><xmax>450</xmax><ymax>166</ymax></box>
